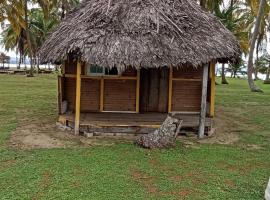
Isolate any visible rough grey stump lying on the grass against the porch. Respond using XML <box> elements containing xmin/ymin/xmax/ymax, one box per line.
<box><xmin>135</xmin><ymin>116</ymin><xmax>183</xmax><ymax>149</ymax></box>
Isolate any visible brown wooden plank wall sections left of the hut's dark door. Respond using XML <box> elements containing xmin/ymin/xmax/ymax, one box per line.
<box><xmin>62</xmin><ymin>60</ymin><xmax>137</xmax><ymax>113</ymax></box>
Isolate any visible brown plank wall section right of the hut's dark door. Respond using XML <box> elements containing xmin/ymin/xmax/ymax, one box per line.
<box><xmin>172</xmin><ymin>66</ymin><xmax>203</xmax><ymax>112</ymax></box>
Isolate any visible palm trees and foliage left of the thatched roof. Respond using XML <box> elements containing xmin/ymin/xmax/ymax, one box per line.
<box><xmin>0</xmin><ymin>0</ymin><xmax>79</xmax><ymax>76</ymax></box>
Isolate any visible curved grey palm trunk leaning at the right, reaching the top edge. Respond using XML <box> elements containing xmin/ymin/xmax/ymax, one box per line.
<box><xmin>247</xmin><ymin>0</ymin><xmax>266</xmax><ymax>92</ymax></box>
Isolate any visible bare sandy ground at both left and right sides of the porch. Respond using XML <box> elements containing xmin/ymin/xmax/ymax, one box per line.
<box><xmin>9</xmin><ymin>107</ymin><xmax>255</xmax><ymax>149</ymax></box>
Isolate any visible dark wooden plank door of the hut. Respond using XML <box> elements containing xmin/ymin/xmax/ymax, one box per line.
<box><xmin>140</xmin><ymin>67</ymin><xmax>169</xmax><ymax>113</ymax></box>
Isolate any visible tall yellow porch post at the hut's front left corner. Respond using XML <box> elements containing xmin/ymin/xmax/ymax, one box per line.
<box><xmin>75</xmin><ymin>61</ymin><xmax>81</xmax><ymax>135</ymax></box>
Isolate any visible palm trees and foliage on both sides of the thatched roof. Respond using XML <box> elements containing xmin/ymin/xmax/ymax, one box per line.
<box><xmin>0</xmin><ymin>0</ymin><xmax>270</xmax><ymax>87</ymax></box>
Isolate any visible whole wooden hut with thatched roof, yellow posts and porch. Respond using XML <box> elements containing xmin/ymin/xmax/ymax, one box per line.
<box><xmin>40</xmin><ymin>0</ymin><xmax>241</xmax><ymax>137</ymax></box>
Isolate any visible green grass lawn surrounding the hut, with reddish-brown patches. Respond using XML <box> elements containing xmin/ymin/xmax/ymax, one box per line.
<box><xmin>0</xmin><ymin>75</ymin><xmax>270</xmax><ymax>200</ymax></box>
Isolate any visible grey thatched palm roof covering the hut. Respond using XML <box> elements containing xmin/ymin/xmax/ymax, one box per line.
<box><xmin>40</xmin><ymin>0</ymin><xmax>241</xmax><ymax>67</ymax></box>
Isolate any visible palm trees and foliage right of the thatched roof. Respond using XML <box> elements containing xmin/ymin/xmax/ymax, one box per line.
<box><xmin>199</xmin><ymin>0</ymin><xmax>270</xmax><ymax>92</ymax></box>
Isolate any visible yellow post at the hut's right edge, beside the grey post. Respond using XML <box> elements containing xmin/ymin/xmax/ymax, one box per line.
<box><xmin>210</xmin><ymin>61</ymin><xmax>216</xmax><ymax>117</ymax></box>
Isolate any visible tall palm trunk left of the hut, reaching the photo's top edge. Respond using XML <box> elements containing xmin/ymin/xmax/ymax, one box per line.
<box><xmin>24</xmin><ymin>0</ymin><xmax>34</xmax><ymax>77</ymax></box>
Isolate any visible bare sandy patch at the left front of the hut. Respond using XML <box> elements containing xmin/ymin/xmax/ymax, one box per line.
<box><xmin>9</xmin><ymin>122</ymin><xmax>131</xmax><ymax>149</ymax></box>
